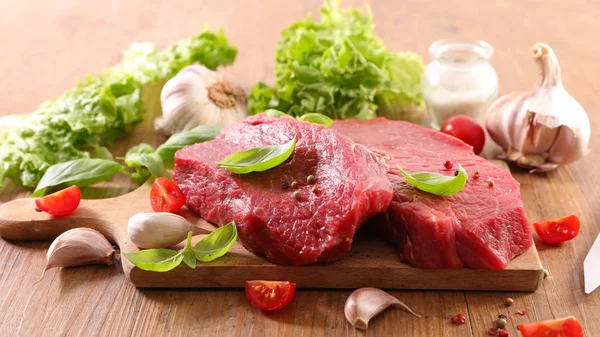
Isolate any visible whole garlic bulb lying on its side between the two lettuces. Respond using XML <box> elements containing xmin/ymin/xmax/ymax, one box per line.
<box><xmin>154</xmin><ymin>65</ymin><xmax>248</xmax><ymax>136</ymax></box>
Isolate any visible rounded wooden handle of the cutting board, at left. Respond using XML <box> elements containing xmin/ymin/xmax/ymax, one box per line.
<box><xmin>0</xmin><ymin>194</ymin><xmax>123</xmax><ymax>245</ymax></box>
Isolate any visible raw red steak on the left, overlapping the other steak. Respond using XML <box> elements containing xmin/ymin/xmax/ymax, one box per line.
<box><xmin>173</xmin><ymin>114</ymin><xmax>392</xmax><ymax>265</ymax></box>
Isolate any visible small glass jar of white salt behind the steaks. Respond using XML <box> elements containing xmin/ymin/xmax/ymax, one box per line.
<box><xmin>421</xmin><ymin>40</ymin><xmax>498</xmax><ymax>130</ymax></box>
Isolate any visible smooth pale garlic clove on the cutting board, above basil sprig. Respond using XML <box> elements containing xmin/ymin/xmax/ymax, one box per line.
<box><xmin>127</xmin><ymin>212</ymin><xmax>190</xmax><ymax>248</ymax></box>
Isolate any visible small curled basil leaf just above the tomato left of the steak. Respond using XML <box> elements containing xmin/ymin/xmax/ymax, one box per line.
<box><xmin>125</xmin><ymin>144</ymin><xmax>165</xmax><ymax>185</ymax></box>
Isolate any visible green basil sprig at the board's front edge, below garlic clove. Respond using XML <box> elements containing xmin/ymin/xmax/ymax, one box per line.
<box><xmin>124</xmin><ymin>222</ymin><xmax>237</xmax><ymax>272</ymax></box>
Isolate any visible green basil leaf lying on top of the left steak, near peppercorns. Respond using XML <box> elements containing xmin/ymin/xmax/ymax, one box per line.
<box><xmin>217</xmin><ymin>137</ymin><xmax>296</xmax><ymax>174</ymax></box>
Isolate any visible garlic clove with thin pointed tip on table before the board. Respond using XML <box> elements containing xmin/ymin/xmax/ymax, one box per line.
<box><xmin>344</xmin><ymin>288</ymin><xmax>421</xmax><ymax>329</ymax></box>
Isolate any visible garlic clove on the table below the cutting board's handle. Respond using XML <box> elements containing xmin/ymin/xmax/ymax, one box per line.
<box><xmin>42</xmin><ymin>228</ymin><xmax>116</xmax><ymax>277</ymax></box>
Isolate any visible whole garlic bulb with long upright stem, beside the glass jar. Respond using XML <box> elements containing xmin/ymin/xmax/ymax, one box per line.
<box><xmin>486</xmin><ymin>43</ymin><xmax>590</xmax><ymax>172</ymax></box>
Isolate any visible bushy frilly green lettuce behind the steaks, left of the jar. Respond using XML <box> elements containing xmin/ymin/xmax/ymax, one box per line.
<box><xmin>248</xmin><ymin>0</ymin><xmax>424</xmax><ymax>119</ymax></box>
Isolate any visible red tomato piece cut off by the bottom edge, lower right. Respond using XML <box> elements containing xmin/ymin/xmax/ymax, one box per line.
<box><xmin>517</xmin><ymin>317</ymin><xmax>583</xmax><ymax>337</ymax></box>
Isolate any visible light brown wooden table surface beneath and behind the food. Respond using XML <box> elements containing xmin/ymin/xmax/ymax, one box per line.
<box><xmin>0</xmin><ymin>0</ymin><xmax>600</xmax><ymax>337</ymax></box>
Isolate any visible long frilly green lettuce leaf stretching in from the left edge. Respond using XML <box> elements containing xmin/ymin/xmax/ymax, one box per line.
<box><xmin>0</xmin><ymin>29</ymin><xmax>237</xmax><ymax>187</ymax></box>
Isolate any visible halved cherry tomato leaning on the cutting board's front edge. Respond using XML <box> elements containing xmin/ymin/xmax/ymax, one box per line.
<box><xmin>246</xmin><ymin>281</ymin><xmax>296</xmax><ymax>311</ymax></box>
